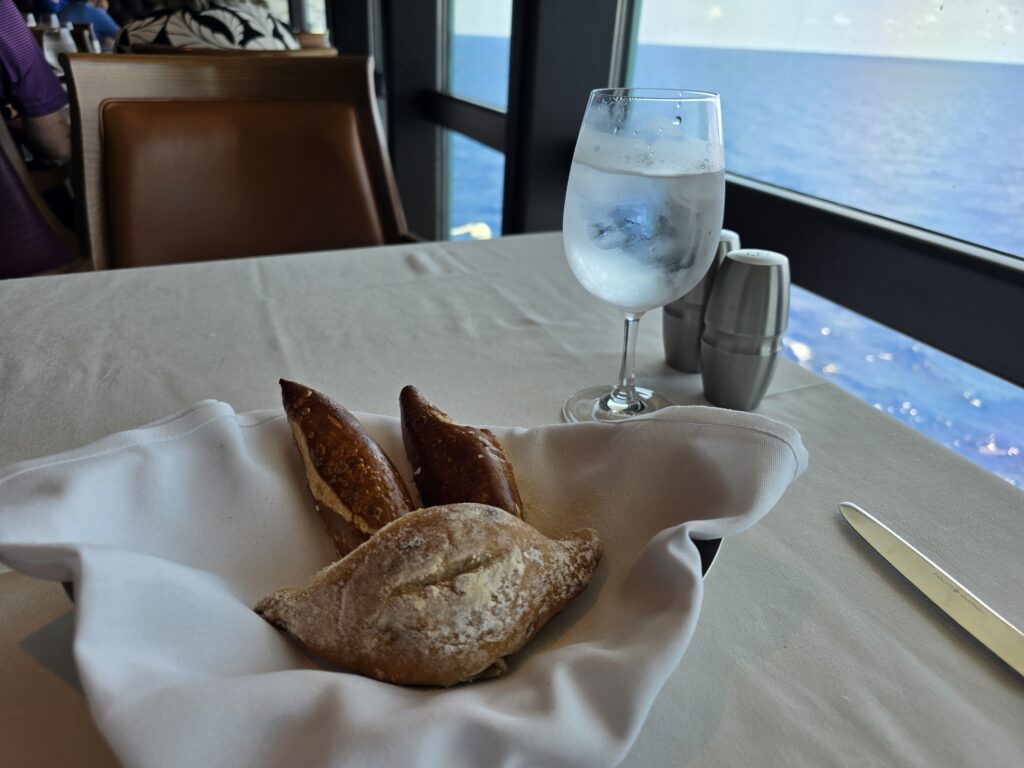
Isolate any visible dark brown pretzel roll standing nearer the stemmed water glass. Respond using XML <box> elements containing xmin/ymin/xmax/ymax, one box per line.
<box><xmin>398</xmin><ymin>386</ymin><xmax>523</xmax><ymax>517</ymax></box>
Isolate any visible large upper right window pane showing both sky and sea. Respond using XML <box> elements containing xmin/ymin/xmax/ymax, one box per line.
<box><xmin>630</xmin><ymin>0</ymin><xmax>1024</xmax><ymax>257</ymax></box>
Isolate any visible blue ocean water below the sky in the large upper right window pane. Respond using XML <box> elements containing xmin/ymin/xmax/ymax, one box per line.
<box><xmin>631</xmin><ymin>45</ymin><xmax>1024</xmax><ymax>258</ymax></box>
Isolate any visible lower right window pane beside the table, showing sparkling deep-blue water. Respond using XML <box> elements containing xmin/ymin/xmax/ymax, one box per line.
<box><xmin>782</xmin><ymin>286</ymin><xmax>1024</xmax><ymax>488</ymax></box>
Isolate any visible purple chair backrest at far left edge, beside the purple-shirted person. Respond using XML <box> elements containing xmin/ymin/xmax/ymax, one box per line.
<box><xmin>0</xmin><ymin>120</ymin><xmax>76</xmax><ymax>278</ymax></box>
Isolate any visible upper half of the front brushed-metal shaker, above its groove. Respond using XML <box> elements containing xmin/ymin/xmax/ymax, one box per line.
<box><xmin>705</xmin><ymin>248</ymin><xmax>790</xmax><ymax>338</ymax></box>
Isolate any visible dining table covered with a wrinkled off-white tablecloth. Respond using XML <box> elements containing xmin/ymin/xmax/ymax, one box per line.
<box><xmin>0</xmin><ymin>232</ymin><xmax>1024</xmax><ymax>768</ymax></box>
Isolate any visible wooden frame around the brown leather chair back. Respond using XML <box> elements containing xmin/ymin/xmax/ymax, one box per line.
<box><xmin>60</xmin><ymin>53</ymin><xmax>412</xmax><ymax>269</ymax></box>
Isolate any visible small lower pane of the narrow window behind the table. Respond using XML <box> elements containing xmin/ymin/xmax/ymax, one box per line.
<box><xmin>444</xmin><ymin>131</ymin><xmax>505</xmax><ymax>240</ymax></box>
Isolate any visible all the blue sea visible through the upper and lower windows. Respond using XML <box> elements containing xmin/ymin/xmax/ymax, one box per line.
<box><xmin>449</xmin><ymin>36</ymin><xmax>1024</xmax><ymax>488</ymax></box>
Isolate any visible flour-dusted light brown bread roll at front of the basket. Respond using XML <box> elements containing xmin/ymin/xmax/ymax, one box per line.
<box><xmin>255</xmin><ymin>504</ymin><xmax>601</xmax><ymax>686</ymax></box>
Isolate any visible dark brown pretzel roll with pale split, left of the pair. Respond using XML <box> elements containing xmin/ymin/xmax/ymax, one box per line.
<box><xmin>281</xmin><ymin>379</ymin><xmax>413</xmax><ymax>557</ymax></box>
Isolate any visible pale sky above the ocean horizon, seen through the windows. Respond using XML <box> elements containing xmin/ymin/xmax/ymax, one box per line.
<box><xmin>452</xmin><ymin>0</ymin><xmax>1024</xmax><ymax>63</ymax></box>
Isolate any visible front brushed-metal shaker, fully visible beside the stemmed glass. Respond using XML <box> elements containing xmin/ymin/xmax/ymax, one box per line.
<box><xmin>700</xmin><ymin>248</ymin><xmax>790</xmax><ymax>411</ymax></box>
